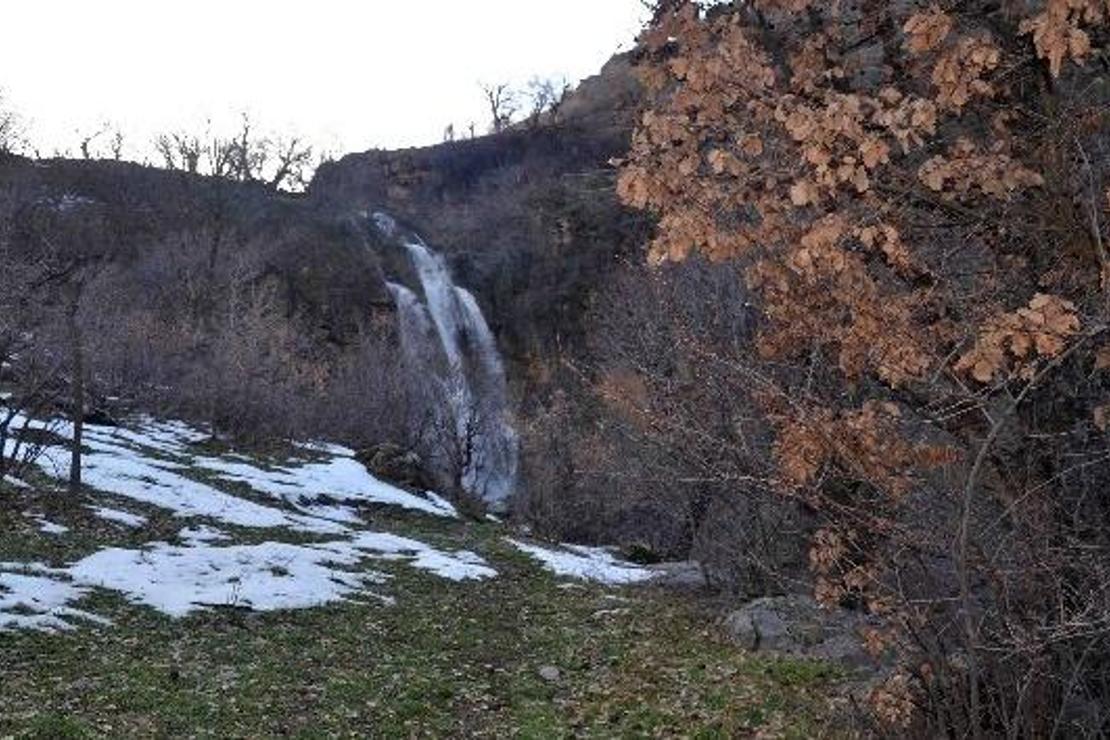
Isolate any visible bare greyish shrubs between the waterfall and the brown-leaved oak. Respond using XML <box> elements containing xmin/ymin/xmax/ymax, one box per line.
<box><xmin>515</xmin><ymin>257</ymin><xmax>813</xmax><ymax>581</ymax></box>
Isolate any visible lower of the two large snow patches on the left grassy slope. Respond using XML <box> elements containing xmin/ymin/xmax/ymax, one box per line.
<box><xmin>0</xmin><ymin>528</ymin><xmax>497</xmax><ymax>631</ymax></box>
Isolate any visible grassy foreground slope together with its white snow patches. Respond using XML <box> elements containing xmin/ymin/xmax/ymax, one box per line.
<box><xmin>0</xmin><ymin>423</ymin><xmax>842</xmax><ymax>738</ymax></box>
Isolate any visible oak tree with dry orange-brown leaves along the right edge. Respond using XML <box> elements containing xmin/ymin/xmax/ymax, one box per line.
<box><xmin>618</xmin><ymin>0</ymin><xmax>1110</xmax><ymax>737</ymax></box>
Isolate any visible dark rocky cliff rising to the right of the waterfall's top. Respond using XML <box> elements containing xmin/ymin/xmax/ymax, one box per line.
<box><xmin>310</xmin><ymin>55</ymin><xmax>643</xmax><ymax>358</ymax></box>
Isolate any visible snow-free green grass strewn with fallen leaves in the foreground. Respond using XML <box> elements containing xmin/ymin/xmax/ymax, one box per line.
<box><xmin>0</xmin><ymin>477</ymin><xmax>837</xmax><ymax>738</ymax></box>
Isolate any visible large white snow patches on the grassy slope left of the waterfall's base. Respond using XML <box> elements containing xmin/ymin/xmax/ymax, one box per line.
<box><xmin>0</xmin><ymin>419</ymin><xmax>497</xmax><ymax>631</ymax></box>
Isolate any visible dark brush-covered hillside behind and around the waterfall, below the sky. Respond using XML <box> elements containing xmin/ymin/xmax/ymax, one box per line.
<box><xmin>0</xmin><ymin>50</ymin><xmax>646</xmax><ymax>503</ymax></box>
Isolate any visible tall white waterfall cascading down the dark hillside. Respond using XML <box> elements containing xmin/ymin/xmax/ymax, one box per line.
<box><xmin>384</xmin><ymin>231</ymin><xmax>518</xmax><ymax>509</ymax></box>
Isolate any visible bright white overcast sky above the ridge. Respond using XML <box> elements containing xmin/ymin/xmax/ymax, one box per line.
<box><xmin>0</xmin><ymin>0</ymin><xmax>644</xmax><ymax>158</ymax></box>
